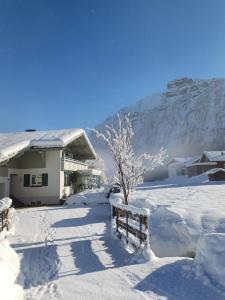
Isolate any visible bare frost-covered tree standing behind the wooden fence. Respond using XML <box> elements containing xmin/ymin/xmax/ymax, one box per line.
<box><xmin>93</xmin><ymin>114</ymin><xmax>166</xmax><ymax>204</ymax></box>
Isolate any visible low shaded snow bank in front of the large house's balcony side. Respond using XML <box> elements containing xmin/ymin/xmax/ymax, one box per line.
<box><xmin>65</xmin><ymin>188</ymin><xmax>109</xmax><ymax>206</ymax></box>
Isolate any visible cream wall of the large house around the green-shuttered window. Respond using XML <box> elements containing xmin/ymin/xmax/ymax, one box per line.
<box><xmin>9</xmin><ymin>150</ymin><xmax>62</xmax><ymax>205</ymax></box>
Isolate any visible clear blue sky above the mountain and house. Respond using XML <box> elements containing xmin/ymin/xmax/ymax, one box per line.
<box><xmin>0</xmin><ymin>0</ymin><xmax>225</xmax><ymax>131</ymax></box>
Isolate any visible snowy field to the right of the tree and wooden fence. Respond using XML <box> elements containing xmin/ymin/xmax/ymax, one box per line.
<box><xmin>132</xmin><ymin>175</ymin><xmax>225</xmax><ymax>257</ymax></box>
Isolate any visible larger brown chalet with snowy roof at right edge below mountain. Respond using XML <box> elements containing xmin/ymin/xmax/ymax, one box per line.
<box><xmin>186</xmin><ymin>151</ymin><xmax>225</xmax><ymax>177</ymax></box>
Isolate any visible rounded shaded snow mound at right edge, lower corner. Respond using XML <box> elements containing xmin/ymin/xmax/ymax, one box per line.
<box><xmin>195</xmin><ymin>233</ymin><xmax>225</xmax><ymax>289</ymax></box>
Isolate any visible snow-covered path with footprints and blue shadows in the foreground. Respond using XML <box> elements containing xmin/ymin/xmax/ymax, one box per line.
<box><xmin>8</xmin><ymin>205</ymin><xmax>225</xmax><ymax>300</ymax></box>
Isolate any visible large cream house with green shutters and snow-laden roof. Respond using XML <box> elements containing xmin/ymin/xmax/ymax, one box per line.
<box><xmin>0</xmin><ymin>129</ymin><xmax>100</xmax><ymax>205</ymax></box>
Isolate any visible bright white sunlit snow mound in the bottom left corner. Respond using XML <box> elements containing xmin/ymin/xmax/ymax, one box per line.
<box><xmin>0</xmin><ymin>239</ymin><xmax>23</xmax><ymax>300</ymax></box>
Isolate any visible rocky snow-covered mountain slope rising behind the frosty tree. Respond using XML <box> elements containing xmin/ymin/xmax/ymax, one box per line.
<box><xmin>90</xmin><ymin>78</ymin><xmax>225</xmax><ymax>156</ymax></box>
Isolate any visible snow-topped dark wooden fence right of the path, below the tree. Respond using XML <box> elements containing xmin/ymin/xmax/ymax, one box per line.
<box><xmin>112</xmin><ymin>204</ymin><xmax>149</xmax><ymax>247</ymax></box>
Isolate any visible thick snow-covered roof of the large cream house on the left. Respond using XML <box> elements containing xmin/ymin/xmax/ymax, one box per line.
<box><xmin>0</xmin><ymin>128</ymin><xmax>96</xmax><ymax>162</ymax></box>
